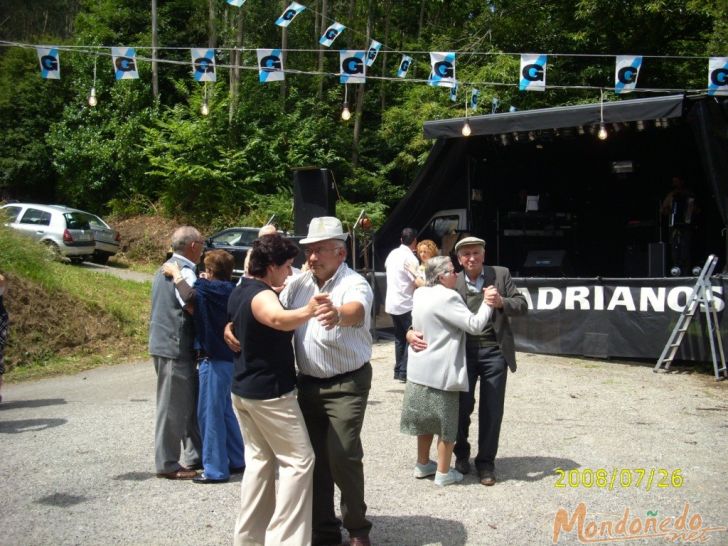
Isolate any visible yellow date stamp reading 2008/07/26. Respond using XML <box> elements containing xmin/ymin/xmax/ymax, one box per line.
<box><xmin>554</xmin><ymin>468</ymin><xmax>685</xmax><ymax>491</ymax></box>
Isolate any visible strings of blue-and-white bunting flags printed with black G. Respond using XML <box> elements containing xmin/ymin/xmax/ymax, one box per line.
<box><xmin>0</xmin><ymin>0</ymin><xmax>728</xmax><ymax>102</ymax></box>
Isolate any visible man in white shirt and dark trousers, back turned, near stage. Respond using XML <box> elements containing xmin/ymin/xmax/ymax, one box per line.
<box><xmin>384</xmin><ymin>228</ymin><xmax>418</xmax><ymax>382</ymax></box>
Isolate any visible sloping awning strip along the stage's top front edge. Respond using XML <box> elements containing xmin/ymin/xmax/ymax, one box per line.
<box><xmin>424</xmin><ymin>95</ymin><xmax>685</xmax><ymax>138</ymax></box>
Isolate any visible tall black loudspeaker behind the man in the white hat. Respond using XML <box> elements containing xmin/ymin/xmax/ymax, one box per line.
<box><xmin>293</xmin><ymin>167</ymin><xmax>336</xmax><ymax>235</ymax></box>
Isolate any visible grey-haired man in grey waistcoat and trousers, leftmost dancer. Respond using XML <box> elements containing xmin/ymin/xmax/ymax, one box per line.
<box><xmin>149</xmin><ymin>226</ymin><xmax>204</xmax><ymax>480</ymax></box>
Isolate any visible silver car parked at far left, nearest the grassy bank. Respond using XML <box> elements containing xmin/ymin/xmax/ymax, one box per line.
<box><xmin>0</xmin><ymin>203</ymin><xmax>96</xmax><ymax>263</ymax></box>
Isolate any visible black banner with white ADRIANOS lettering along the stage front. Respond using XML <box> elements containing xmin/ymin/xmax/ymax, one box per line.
<box><xmin>511</xmin><ymin>277</ymin><xmax>728</xmax><ymax>362</ymax></box>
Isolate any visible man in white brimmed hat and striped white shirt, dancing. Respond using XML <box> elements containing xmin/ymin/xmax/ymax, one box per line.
<box><xmin>226</xmin><ymin>216</ymin><xmax>373</xmax><ymax>546</ymax></box>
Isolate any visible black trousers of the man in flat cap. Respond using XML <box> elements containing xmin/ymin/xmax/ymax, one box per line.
<box><xmin>454</xmin><ymin>347</ymin><xmax>508</xmax><ymax>471</ymax></box>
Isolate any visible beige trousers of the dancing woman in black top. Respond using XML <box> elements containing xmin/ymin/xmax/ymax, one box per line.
<box><xmin>232</xmin><ymin>391</ymin><xmax>315</xmax><ymax>546</ymax></box>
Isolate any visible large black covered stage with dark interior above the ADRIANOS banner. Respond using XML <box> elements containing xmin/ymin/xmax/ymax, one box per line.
<box><xmin>375</xmin><ymin>95</ymin><xmax>728</xmax><ymax>277</ymax></box>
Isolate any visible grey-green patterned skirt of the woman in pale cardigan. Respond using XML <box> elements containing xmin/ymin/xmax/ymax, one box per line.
<box><xmin>399</xmin><ymin>381</ymin><xmax>460</xmax><ymax>442</ymax></box>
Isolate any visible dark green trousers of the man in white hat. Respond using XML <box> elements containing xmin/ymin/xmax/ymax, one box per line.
<box><xmin>298</xmin><ymin>362</ymin><xmax>372</xmax><ymax>546</ymax></box>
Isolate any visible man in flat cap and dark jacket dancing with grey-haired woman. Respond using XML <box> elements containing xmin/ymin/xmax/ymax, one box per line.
<box><xmin>407</xmin><ymin>237</ymin><xmax>528</xmax><ymax>486</ymax></box>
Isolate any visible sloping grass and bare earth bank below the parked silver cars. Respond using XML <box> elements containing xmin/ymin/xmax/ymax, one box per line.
<box><xmin>0</xmin><ymin>226</ymin><xmax>151</xmax><ymax>381</ymax></box>
